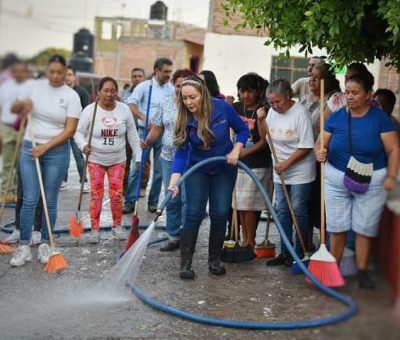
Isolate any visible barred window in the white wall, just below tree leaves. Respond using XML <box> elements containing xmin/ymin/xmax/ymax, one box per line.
<box><xmin>270</xmin><ymin>56</ymin><xmax>308</xmax><ymax>83</ymax></box>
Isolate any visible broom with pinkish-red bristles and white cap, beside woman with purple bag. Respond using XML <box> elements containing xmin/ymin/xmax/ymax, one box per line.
<box><xmin>306</xmin><ymin>79</ymin><xmax>345</xmax><ymax>287</ymax></box>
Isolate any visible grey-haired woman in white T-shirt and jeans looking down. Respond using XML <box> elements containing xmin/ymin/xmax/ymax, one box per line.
<box><xmin>257</xmin><ymin>79</ymin><xmax>315</xmax><ymax>266</ymax></box>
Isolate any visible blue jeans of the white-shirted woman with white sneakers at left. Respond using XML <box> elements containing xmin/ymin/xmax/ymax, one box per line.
<box><xmin>20</xmin><ymin>141</ymin><xmax>70</xmax><ymax>244</ymax></box>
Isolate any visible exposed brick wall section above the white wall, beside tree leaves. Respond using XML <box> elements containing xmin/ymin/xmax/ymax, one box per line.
<box><xmin>209</xmin><ymin>0</ymin><xmax>266</xmax><ymax>36</ymax></box>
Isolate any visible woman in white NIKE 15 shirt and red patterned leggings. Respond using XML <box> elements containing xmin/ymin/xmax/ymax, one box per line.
<box><xmin>75</xmin><ymin>77</ymin><xmax>141</xmax><ymax>243</ymax></box>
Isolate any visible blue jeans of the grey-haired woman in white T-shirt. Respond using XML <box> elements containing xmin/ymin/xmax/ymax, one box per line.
<box><xmin>274</xmin><ymin>183</ymin><xmax>313</xmax><ymax>258</ymax></box>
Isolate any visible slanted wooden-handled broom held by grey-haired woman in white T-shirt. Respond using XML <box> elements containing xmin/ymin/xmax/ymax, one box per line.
<box><xmin>265</xmin><ymin>124</ymin><xmax>310</xmax><ymax>274</ymax></box>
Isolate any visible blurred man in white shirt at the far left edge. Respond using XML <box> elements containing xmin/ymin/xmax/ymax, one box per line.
<box><xmin>0</xmin><ymin>61</ymin><xmax>29</xmax><ymax>203</ymax></box>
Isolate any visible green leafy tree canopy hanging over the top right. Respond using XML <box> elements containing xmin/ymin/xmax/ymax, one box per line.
<box><xmin>222</xmin><ymin>0</ymin><xmax>400</xmax><ymax>69</ymax></box>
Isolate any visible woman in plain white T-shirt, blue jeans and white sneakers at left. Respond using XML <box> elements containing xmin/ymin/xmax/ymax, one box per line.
<box><xmin>10</xmin><ymin>55</ymin><xmax>82</xmax><ymax>266</ymax></box>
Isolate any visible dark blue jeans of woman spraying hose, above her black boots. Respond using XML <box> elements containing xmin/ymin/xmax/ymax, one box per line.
<box><xmin>183</xmin><ymin>167</ymin><xmax>237</xmax><ymax>233</ymax></box>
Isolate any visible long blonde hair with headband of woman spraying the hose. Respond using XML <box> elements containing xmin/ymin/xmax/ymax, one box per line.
<box><xmin>174</xmin><ymin>76</ymin><xmax>214</xmax><ymax>149</ymax></box>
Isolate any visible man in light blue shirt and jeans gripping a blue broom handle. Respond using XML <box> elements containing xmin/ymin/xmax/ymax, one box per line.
<box><xmin>123</xmin><ymin>58</ymin><xmax>174</xmax><ymax>214</ymax></box>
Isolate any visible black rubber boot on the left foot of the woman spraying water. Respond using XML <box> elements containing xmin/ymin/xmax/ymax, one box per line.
<box><xmin>179</xmin><ymin>229</ymin><xmax>199</xmax><ymax>280</ymax></box>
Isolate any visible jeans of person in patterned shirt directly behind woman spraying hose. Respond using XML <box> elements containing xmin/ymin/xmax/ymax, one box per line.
<box><xmin>161</xmin><ymin>158</ymin><xmax>185</xmax><ymax>239</ymax></box>
